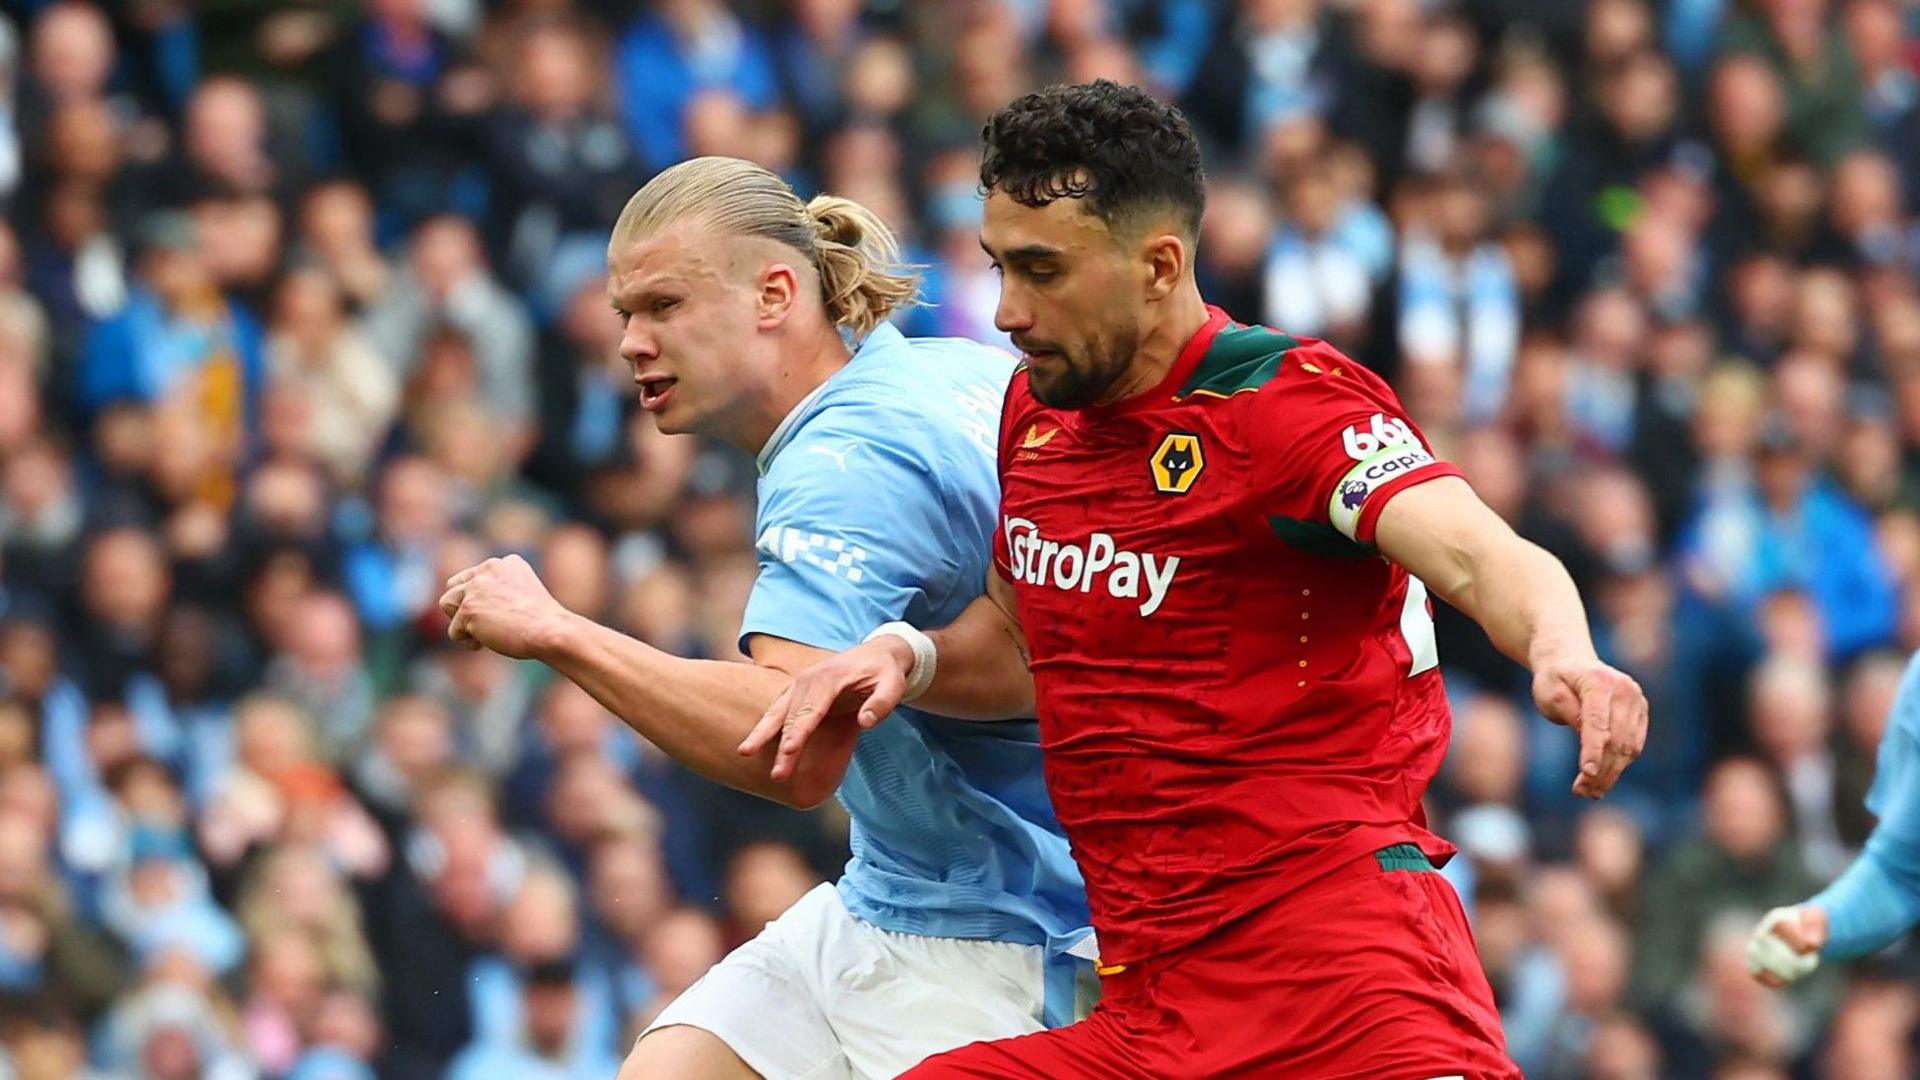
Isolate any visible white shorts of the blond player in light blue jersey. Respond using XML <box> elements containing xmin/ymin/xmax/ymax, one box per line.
<box><xmin>641</xmin><ymin>884</ymin><xmax>1044</xmax><ymax>1080</ymax></box>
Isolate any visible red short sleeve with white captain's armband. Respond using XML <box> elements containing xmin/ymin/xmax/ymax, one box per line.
<box><xmin>1250</xmin><ymin>342</ymin><xmax>1461</xmax><ymax>546</ymax></box>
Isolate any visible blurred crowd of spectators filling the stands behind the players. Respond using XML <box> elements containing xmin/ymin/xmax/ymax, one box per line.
<box><xmin>0</xmin><ymin>0</ymin><xmax>1920</xmax><ymax>1080</ymax></box>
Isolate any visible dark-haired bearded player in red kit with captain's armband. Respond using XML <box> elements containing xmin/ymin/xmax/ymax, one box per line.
<box><xmin>749</xmin><ymin>83</ymin><xmax>1647</xmax><ymax>1080</ymax></box>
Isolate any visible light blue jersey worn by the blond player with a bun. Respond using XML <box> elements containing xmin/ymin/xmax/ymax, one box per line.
<box><xmin>741</xmin><ymin>327</ymin><xmax>1089</xmax><ymax>1022</ymax></box>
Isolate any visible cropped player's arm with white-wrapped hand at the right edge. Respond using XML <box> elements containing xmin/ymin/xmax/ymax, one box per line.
<box><xmin>1747</xmin><ymin>653</ymin><xmax>1920</xmax><ymax>988</ymax></box>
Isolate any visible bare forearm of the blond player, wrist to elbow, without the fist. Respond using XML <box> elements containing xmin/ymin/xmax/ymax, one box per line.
<box><xmin>538</xmin><ymin>617</ymin><xmax>843</xmax><ymax>805</ymax></box>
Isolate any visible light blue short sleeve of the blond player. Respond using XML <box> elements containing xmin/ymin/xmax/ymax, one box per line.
<box><xmin>739</xmin><ymin>405</ymin><xmax>977</xmax><ymax>651</ymax></box>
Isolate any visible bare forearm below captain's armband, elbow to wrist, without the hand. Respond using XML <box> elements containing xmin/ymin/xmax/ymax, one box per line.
<box><xmin>1427</xmin><ymin>532</ymin><xmax>1594</xmax><ymax>671</ymax></box>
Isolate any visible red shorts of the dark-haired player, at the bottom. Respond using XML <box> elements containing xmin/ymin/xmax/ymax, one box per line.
<box><xmin>904</xmin><ymin>846</ymin><xmax>1521</xmax><ymax>1080</ymax></box>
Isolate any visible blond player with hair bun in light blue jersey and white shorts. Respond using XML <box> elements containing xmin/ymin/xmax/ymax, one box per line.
<box><xmin>442</xmin><ymin>158</ymin><xmax>1091</xmax><ymax>1080</ymax></box>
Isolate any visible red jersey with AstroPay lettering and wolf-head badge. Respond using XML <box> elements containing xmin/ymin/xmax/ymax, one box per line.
<box><xmin>995</xmin><ymin>307</ymin><xmax>1459</xmax><ymax>963</ymax></box>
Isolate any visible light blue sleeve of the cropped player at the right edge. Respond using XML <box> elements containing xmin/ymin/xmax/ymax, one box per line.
<box><xmin>1811</xmin><ymin>653</ymin><xmax>1920</xmax><ymax>959</ymax></box>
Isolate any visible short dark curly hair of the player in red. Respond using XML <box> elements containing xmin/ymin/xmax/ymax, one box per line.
<box><xmin>979</xmin><ymin>79</ymin><xmax>1206</xmax><ymax>234</ymax></box>
